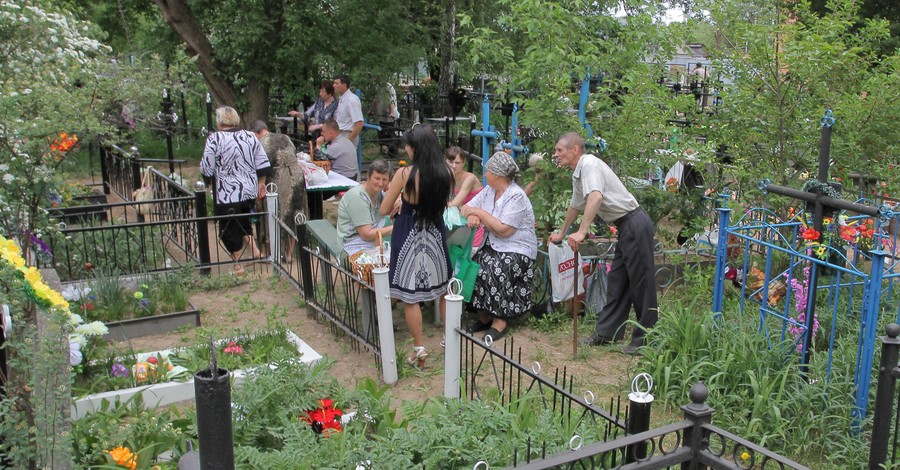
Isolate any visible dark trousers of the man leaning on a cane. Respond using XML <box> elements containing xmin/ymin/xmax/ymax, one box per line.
<box><xmin>594</xmin><ymin>209</ymin><xmax>659</xmax><ymax>341</ymax></box>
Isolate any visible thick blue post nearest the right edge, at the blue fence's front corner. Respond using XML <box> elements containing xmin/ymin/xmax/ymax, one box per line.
<box><xmin>851</xmin><ymin>250</ymin><xmax>888</xmax><ymax>432</ymax></box>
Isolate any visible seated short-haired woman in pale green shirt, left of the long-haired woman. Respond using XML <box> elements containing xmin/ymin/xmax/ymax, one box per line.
<box><xmin>337</xmin><ymin>159</ymin><xmax>393</xmax><ymax>262</ymax></box>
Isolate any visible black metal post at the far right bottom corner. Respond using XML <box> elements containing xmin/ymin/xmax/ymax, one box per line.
<box><xmin>869</xmin><ymin>323</ymin><xmax>900</xmax><ymax>469</ymax></box>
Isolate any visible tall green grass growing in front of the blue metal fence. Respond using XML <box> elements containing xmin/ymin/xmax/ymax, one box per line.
<box><xmin>641</xmin><ymin>302</ymin><xmax>864</xmax><ymax>468</ymax></box>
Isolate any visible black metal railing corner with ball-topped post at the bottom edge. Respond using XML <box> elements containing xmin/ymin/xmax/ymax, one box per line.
<box><xmin>510</xmin><ymin>383</ymin><xmax>807</xmax><ymax>470</ymax></box>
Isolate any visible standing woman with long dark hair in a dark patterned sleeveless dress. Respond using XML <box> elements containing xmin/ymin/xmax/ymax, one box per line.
<box><xmin>381</xmin><ymin>125</ymin><xmax>453</xmax><ymax>367</ymax></box>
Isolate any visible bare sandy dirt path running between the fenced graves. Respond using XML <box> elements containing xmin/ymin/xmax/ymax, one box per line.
<box><xmin>123</xmin><ymin>273</ymin><xmax>638</xmax><ymax>416</ymax></box>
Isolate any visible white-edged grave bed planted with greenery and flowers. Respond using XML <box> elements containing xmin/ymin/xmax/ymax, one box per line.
<box><xmin>72</xmin><ymin>328</ymin><xmax>321</xmax><ymax>418</ymax></box>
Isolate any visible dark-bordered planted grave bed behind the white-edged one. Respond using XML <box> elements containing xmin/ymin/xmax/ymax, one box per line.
<box><xmin>63</xmin><ymin>273</ymin><xmax>200</xmax><ymax>341</ymax></box>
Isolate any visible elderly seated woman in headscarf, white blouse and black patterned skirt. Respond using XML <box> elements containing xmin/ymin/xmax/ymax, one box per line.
<box><xmin>460</xmin><ymin>152</ymin><xmax>537</xmax><ymax>340</ymax></box>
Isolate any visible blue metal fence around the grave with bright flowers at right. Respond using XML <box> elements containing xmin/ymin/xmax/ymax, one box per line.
<box><xmin>712</xmin><ymin>200</ymin><xmax>900</xmax><ymax>425</ymax></box>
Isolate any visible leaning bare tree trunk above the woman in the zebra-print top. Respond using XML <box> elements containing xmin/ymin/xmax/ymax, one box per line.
<box><xmin>155</xmin><ymin>0</ymin><xmax>237</xmax><ymax>106</ymax></box>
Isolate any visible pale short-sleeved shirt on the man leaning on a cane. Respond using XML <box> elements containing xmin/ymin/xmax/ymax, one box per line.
<box><xmin>569</xmin><ymin>154</ymin><xmax>639</xmax><ymax>223</ymax></box>
